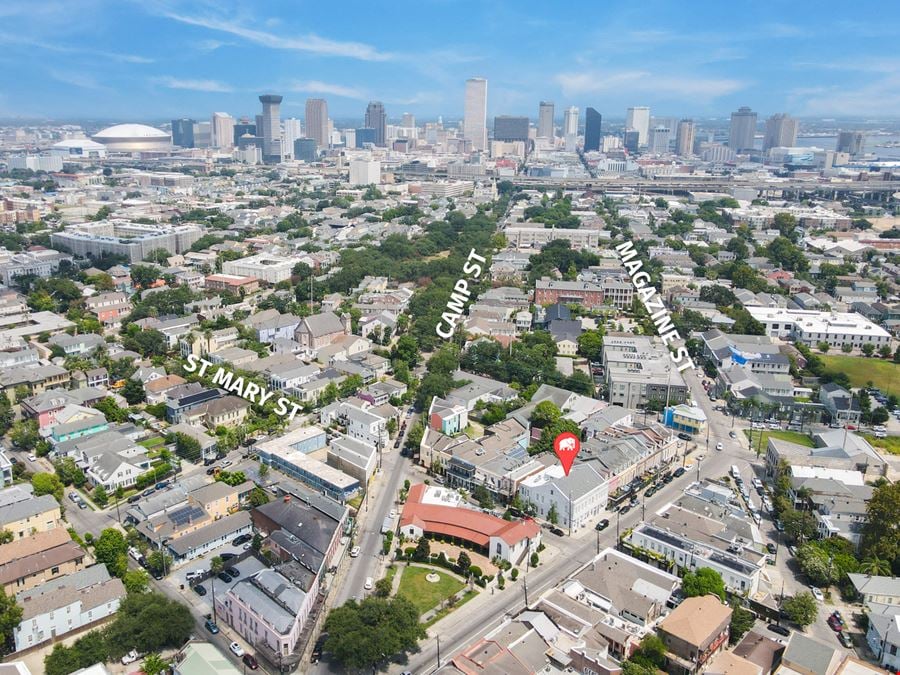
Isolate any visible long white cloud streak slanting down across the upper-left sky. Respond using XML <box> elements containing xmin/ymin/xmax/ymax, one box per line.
<box><xmin>162</xmin><ymin>10</ymin><xmax>392</xmax><ymax>61</ymax></box>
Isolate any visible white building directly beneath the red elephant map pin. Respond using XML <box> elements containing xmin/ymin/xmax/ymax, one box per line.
<box><xmin>519</xmin><ymin>464</ymin><xmax>609</xmax><ymax>530</ymax></box>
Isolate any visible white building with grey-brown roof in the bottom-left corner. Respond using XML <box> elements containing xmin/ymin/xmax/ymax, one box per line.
<box><xmin>13</xmin><ymin>565</ymin><xmax>125</xmax><ymax>651</ymax></box>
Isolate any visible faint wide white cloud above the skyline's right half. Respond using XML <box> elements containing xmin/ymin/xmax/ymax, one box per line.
<box><xmin>556</xmin><ymin>70</ymin><xmax>746</xmax><ymax>101</ymax></box>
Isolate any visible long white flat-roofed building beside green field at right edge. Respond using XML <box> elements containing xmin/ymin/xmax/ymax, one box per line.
<box><xmin>747</xmin><ymin>307</ymin><xmax>891</xmax><ymax>348</ymax></box>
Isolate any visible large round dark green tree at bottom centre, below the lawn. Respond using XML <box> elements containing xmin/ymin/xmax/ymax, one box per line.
<box><xmin>325</xmin><ymin>596</ymin><xmax>426</xmax><ymax>670</ymax></box>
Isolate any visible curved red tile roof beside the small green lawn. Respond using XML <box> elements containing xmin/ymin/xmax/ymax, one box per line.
<box><xmin>400</xmin><ymin>483</ymin><xmax>540</xmax><ymax>546</ymax></box>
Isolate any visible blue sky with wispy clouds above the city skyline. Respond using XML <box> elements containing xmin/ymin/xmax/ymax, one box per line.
<box><xmin>0</xmin><ymin>0</ymin><xmax>900</xmax><ymax>122</ymax></box>
